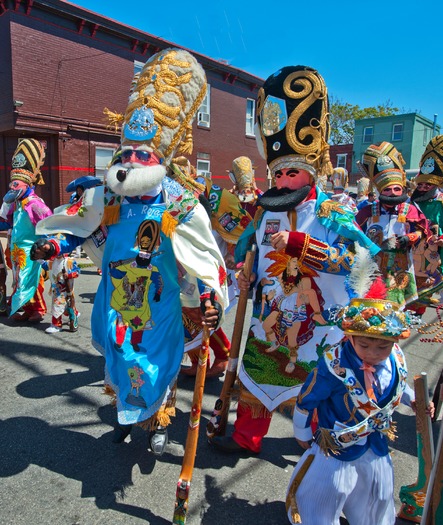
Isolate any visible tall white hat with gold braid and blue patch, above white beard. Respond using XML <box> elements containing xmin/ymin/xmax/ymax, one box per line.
<box><xmin>104</xmin><ymin>49</ymin><xmax>206</xmax><ymax>164</ymax></box>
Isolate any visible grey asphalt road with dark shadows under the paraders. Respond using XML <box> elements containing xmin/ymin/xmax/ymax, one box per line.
<box><xmin>0</xmin><ymin>260</ymin><xmax>443</xmax><ymax>525</ymax></box>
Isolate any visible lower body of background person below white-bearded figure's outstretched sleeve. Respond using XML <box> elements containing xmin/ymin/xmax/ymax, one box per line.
<box><xmin>43</xmin><ymin>249</ymin><xmax>80</xmax><ymax>334</ymax></box>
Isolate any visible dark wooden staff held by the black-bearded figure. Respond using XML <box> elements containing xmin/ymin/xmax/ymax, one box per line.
<box><xmin>206</xmin><ymin>244</ymin><xmax>257</xmax><ymax>439</ymax></box>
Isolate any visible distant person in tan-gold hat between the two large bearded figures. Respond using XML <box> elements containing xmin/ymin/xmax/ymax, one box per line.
<box><xmin>228</xmin><ymin>157</ymin><xmax>263</xmax><ymax>218</ymax></box>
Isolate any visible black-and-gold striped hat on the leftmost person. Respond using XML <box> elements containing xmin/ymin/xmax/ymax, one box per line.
<box><xmin>11</xmin><ymin>139</ymin><xmax>45</xmax><ymax>186</ymax></box>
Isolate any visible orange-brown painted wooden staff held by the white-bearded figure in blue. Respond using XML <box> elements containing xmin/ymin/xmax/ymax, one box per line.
<box><xmin>172</xmin><ymin>300</ymin><xmax>211</xmax><ymax>525</ymax></box>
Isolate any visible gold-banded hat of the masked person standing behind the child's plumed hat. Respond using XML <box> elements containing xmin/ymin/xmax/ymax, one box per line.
<box><xmin>362</xmin><ymin>142</ymin><xmax>406</xmax><ymax>193</ymax></box>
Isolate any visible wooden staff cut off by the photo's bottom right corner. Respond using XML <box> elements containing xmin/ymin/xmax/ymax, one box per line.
<box><xmin>421</xmin><ymin>380</ymin><xmax>443</xmax><ymax>525</ymax></box>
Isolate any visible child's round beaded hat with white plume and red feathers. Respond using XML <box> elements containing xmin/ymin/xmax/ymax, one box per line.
<box><xmin>335</xmin><ymin>244</ymin><xmax>416</xmax><ymax>340</ymax></box>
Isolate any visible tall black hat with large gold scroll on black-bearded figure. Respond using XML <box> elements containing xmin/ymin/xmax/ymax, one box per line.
<box><xmin>257</xmin><ymin>66</ymin><xmax>332</xmax><ymax>177</ymax></box>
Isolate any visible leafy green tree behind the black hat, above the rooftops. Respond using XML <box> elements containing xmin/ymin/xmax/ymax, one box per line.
<box><xmin>329</xmin><ymin>97</ymin><xmax>400</xmax><ymax>145</ymax></box>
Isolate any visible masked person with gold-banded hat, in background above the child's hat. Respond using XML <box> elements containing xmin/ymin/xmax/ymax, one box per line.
<box><xmin>356</xmin><ymin>142</ymin><xmax>429</xmax><ymax>308</ymax></box>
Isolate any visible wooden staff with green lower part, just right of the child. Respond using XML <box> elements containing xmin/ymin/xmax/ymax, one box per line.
<box><xmin>398</xmin><ymin>372</ymin><xmax>434</xmax><ymax>523</ymax></box>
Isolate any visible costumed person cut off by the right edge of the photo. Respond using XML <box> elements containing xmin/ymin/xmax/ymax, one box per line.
<box><xmin>411</xmin><ymin>135</ymin><xmax>443</xmax><ymax>305</ymax></box>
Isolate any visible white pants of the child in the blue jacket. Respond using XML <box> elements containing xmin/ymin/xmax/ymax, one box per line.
<box><xmin>288</xmin><ymin>444</ymin><xmax>395</xmax><ymax>525</ymax></box>
